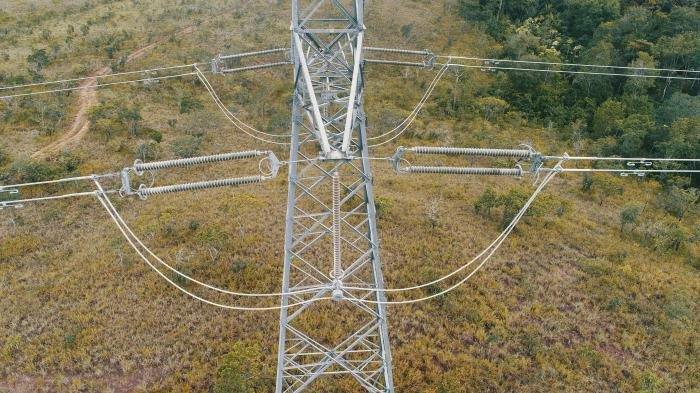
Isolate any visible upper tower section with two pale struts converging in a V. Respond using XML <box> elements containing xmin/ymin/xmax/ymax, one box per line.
<box><xmin>292</xmin><ymin>0</ymin><xmax>364</xmax><ymax>158</ymax></box>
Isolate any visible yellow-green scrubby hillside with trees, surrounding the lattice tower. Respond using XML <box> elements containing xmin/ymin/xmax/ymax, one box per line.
<box><xmin>0</xmin><ymin>0</ymin><xmax>700</xmax><ymax>393</ymax></box>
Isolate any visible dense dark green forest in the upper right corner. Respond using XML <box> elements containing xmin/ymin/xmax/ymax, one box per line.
<box><xmin>454</xmin><ymin>0</ymin><xmax>700</xmax><ymax>179</ymax></box>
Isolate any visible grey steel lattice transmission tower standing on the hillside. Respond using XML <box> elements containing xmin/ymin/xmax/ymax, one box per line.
<box><xmin>277</xmin><ymin>0</ymin><xmax>394</xmax><ymax>393</ymax></box>
